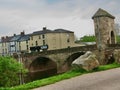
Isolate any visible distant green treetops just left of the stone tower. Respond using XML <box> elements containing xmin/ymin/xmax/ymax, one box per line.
<box><xmin>76</xmin><ymin>35</ymin><xmax>96</xmax><ymax>43</ymax></box>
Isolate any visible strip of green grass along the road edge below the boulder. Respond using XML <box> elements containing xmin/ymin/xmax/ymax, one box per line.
<box><xmin>0</xmin><ymin>63</ymin><xmax>120</xmax><ymax>90</ymax></box>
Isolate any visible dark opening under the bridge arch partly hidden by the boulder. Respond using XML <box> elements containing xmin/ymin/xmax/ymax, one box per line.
<box><xmin>62</xmin><ymin>52</ymin><xmax>85</xmax><ymax>72</ymax></box>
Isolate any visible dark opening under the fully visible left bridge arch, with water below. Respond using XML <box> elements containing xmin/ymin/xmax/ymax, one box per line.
<box><xmin>29</xmin><ymin>57</ymin><xmax>57</xmax><ymax>81</ymax></box>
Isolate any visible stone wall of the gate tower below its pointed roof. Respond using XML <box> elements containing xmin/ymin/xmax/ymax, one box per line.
<box><xmin>94</xmin><ymin>17</ymin><xmax>115</xmax><ymax>49</ymax></box>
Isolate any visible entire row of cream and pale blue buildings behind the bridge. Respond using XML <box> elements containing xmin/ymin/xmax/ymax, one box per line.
<box><xmin>0</xmin><ymin>27</ymin><xmax>75</xmax><ymax>55</ymax></box>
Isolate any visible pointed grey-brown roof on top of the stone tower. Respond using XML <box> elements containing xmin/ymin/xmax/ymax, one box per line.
<box><xmin>92</xmin><ymin>8</ymin><xmax>115</xmax><ymax>19</ymax></box>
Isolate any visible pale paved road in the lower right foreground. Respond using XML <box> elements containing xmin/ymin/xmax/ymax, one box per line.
<box><xmin>34</xmin><ymin>68</ymin><xmax>120</xmax><ymax>90</ymax></box>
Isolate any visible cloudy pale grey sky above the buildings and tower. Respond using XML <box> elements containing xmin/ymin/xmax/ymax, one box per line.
<box><xmin>0</xmin><ymin>0</ymin><xmax>120</xmax><ymax>38</ymax></box>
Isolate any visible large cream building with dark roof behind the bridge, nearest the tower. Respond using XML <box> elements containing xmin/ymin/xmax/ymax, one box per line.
<box><xmin>30</xmin><ymin>27</ymin><xmax>75</xmax><ymax>51</ymax></box>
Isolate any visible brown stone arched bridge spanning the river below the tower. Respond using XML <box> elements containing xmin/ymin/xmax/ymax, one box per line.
<box><xmin>21</xmin><ymin>44</ymin><xmax>120</xmax><ymax>72</ymax></box>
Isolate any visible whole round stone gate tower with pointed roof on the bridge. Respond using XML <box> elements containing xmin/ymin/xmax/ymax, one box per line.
<box><xmin>92</xmin><ymin>9</ymin><xmax>116</xmax><ymax>50</ymax></box>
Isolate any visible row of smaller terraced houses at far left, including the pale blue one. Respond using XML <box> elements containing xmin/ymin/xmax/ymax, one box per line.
<box><xmin>0</xmin><ymin>32</ymin><xmax>30</xmax><ymax>56</ymax></box>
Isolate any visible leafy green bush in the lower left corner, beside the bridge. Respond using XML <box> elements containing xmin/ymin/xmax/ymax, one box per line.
<box><xmin>0</xmin><ymin>56</ymin><xmax>25</xmax><ymax>87</ymax></box>
